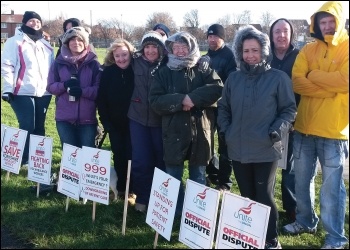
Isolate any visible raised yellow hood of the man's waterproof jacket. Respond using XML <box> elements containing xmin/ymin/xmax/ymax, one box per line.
<box><xmin>310</xmin><ymin>1</ymin><xmax>348</xmax><ymax>46</ymax></box>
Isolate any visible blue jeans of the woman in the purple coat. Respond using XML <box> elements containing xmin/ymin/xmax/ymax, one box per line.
<box><xmin>56</xmin><ymin>121</ymin><xmax>97</xmax><ymax>148</ymax></box>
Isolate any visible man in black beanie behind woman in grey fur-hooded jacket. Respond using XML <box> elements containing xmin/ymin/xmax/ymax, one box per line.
<box><xmin>206</xmin><ymin>24</ymin><xmax>237</xmax><ymax>191</ymax></box>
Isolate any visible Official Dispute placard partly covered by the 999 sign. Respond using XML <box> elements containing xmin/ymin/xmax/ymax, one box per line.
<box><xmin>57</xmin><ymin>143</ymin><xmax>81</xmax><ymax>201</ymax></box>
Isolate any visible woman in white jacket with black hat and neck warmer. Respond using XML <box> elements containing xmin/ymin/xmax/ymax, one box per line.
<box><xmin>1</xmin><ymin>11</ymin><xmax>54</xmax><ymax>165</ymax></box>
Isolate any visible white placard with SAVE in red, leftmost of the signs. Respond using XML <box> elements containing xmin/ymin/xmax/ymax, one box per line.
<box><xmin>1</xmin><ymin>127</ymin><xmax>28</xmax><ymax>174</ymax></box>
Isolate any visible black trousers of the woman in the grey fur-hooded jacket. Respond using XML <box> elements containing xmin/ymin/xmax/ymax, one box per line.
<box><xmin>232</xmin><ymin>161</ymin><xmax>278</xmax><ymax>241</ymax></box>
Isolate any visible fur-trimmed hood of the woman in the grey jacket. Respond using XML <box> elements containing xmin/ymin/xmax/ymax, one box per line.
<box><xmin>232</xmin><ymin>25</ymin><xmax>273</xmax><ymax>68</ymax></box>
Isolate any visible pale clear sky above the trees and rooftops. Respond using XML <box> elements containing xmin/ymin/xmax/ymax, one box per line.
<box><xmin>1</xmin><ymin>1</ymin><xmax>349</xmax><ymax>26</ymax></box>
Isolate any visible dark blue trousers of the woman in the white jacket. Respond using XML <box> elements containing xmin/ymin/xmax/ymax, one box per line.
<box><xmin>10</xmin><ymin>95</ymin><xmax>52</xmax><ymax>164</ymax></box>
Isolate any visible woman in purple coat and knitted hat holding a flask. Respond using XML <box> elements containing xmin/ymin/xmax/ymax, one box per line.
<box><xmin>47</xmin><ymin>27</ymin><xmax>101</xmax><ymax>147</ymax></box>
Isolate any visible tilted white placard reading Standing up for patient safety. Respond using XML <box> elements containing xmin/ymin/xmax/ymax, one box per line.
<box><xmin>146</xmin><ymin>168</ymin><xmax>180</xmax><ymax>241</ymax></box>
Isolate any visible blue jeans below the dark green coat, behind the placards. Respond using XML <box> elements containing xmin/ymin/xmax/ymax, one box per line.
<box><xmin>166</xmin><ymin>165</ymin><xmax>206</xmax><ymax>215</ymax></box>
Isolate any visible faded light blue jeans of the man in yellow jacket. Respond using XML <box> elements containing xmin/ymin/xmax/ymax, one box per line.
<box><xmin>293</xmin><ymin>131</ymin><xmax>349</xmax><ymax>246</ymax></box>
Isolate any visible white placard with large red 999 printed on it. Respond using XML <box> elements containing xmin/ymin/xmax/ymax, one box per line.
<box><xmin>79</xmin><ymin>146</ymin><xmax>111</xmax><ymax>205</ymax></box>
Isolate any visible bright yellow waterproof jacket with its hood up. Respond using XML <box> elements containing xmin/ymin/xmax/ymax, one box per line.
<box><xmin>292</xmin><ymin>1</ymin><xmax>349</xmax><ymax>139</ymax></box>
